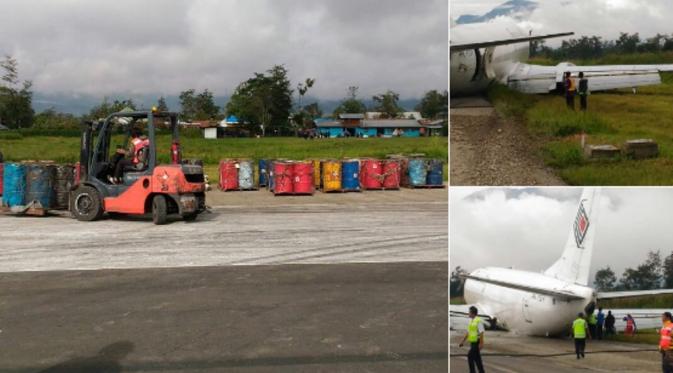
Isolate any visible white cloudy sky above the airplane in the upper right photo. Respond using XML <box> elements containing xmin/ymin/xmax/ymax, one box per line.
<box><xmin>451</xmin><ymin>0</ymin><xmax>673</xmax><ymax>45</ymax></box>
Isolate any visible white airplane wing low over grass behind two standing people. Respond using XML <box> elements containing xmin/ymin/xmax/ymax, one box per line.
<box><xmin>502</xmin><ymin>63</ymin><xmax>673</xmax><ymax>93</ymax></box>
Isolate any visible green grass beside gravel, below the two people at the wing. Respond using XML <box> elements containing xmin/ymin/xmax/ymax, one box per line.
<box><xmin>490</xmin><ymin>71</ymin><xmax>673</xmax><ymax>185</ymax></box>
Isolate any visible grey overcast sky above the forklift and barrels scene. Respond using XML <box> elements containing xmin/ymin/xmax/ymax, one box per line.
<box><xmin>0</xmin><ymin>0</ymin><xmax>449</xmax><ymax>98</ymax></box>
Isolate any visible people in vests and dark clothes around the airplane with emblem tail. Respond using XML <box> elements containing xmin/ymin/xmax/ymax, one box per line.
<box><xmin>459</xmin><ymin>306</ymin><xmax>673</xmax><ymax>373</ymax></box>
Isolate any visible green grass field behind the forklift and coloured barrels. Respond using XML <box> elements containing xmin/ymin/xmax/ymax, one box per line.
<box><xmin>0</xmin><ymin>133</ymin><xmax>448</xmax><ymax>182</ymax></box>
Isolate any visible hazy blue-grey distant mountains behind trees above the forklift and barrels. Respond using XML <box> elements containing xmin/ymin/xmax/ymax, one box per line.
<box><xmin>33</xmin><ymin>92</ymin><xmax>420</xmax><ymax>115</ymax></box>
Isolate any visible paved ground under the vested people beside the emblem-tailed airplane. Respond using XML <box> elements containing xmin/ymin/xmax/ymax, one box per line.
<box><xmin>450</xmin><ymin>331</ymin><xmax>661</xmax><ymax>373</ymax></box>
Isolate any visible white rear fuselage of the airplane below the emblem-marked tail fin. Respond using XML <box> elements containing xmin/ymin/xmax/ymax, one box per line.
<box><xmin>464</xmin><ymin>268</ymin><xmax>595</xmax><ymax>336</ymax></box>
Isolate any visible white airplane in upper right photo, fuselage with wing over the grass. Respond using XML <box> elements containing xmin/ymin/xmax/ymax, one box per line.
<box><xmin>449</xmin><ymin>20</ymin><xmax>673</xmax><ymax>96</ymax></box>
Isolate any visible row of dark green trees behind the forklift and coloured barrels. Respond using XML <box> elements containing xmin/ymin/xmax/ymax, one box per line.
<box><xmin>0</xmin><ymin>56</ymin><xmax>448</xmax><ymax>135</ymax></box>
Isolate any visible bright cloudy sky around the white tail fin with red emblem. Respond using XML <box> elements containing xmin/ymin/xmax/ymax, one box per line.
<box><xmin>449</xmin><ymin>187</ymin><xmax>673</xmax><ymax>286</ymax></box>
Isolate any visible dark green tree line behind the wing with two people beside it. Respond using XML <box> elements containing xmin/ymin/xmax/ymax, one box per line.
<box><xmin>530</xmin><ymin>32</ymin><xmax>673</xmax><ymax>61</ymax></box>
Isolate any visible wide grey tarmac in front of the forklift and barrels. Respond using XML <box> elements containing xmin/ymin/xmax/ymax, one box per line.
<box><xmin>0</xmin><ymin>190</ymin><xmax>448</xmax><ymax>373</ymax></box>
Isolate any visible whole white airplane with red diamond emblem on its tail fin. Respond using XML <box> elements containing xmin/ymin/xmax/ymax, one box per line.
<box><xmin>450</xmin><ymin>188</ymin><xmax>673</xmax><ymax>336</ymax></box>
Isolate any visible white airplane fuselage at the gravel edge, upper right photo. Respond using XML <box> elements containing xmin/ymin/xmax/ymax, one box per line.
<box><xmin>450</xmin><ymin>23</ymin><xmax>529</xmax><ymax>96</ymax></box>
